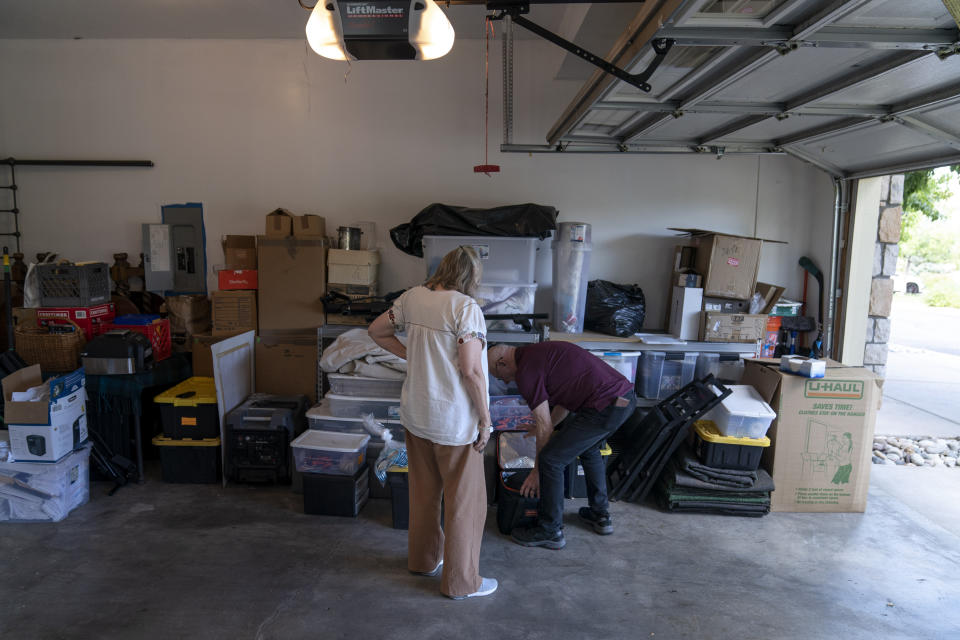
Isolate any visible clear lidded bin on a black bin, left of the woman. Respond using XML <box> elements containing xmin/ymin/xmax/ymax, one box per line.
<box><xmin>291</xmin><ymin>429</ymin><xmax>370</xmax><ymax>517</ymax></box>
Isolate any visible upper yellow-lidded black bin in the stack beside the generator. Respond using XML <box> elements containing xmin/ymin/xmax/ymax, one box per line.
<box><xmin>153</xmin><ymin>376</ymin><xmax>220</xmax><ymax>439</ymax></box>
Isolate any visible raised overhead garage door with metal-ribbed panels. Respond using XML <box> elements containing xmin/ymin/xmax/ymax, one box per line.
<box><xmin>532</xmin><ymin>0</ymin><xmax>960</xmax><ymax>178</ymax></box>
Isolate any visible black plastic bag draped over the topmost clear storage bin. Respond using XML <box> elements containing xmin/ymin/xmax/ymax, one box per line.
<box><xmin>390</xmin><ymin>203</ymin><xmax>557</xmax><ymax>258</ymax></box>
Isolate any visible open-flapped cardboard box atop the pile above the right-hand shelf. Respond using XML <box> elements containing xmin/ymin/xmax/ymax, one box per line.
<box><xmin>671</xmin><ymin>227</ymin><xmax>778</xmax><ymax>300</ymax></box>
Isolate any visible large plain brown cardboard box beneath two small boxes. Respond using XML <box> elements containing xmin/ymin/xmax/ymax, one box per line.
<box><xmin>257</xmin><ymin>237</ymin><xmax>328</xmax><ymax>331</ymax></box>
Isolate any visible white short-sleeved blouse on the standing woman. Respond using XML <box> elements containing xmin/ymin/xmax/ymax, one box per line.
<box><xmin>388</xmin><ymin>286</ymin><xmax>489</xmax><ymax>446</ymax></box>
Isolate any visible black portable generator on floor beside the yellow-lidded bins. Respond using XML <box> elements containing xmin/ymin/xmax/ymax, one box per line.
<box><xmin>224</xmin><ymin>393</ymin><xmax>307</xmax><ymax>483</ymax></box>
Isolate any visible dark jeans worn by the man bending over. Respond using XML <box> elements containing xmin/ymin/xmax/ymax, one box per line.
<box><xmin>537</xmin><ymin>391</ymin><xmax>637</xmax><ymax>532</ymax></box>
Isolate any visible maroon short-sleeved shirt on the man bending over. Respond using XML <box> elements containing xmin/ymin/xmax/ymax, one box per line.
<box><xmin>514</xmin><ymin>342</ymin><xmax>633</xmax><ymax>412</ymax></box>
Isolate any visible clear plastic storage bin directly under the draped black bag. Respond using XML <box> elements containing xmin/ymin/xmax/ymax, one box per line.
<box><xmin>423</xmin><ymin>236</ymin><xmax>540</xmax><ymax>284</ymax></box>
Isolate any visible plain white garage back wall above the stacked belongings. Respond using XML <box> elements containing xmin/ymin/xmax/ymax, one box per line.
<box><xmin>0</xmin><ymin>40</ymin><xmax>833</xmax><ymax>328</ymax></box>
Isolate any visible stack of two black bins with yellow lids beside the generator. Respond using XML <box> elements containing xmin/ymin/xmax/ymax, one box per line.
<box><xmin>153</xmin><ymin>377</ymin><xmax>221</xmax><ymax>484</ymax></box>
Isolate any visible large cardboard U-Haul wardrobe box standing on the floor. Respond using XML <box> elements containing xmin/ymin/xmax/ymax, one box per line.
<box><xmin>743</xmin><ymin>360</ymin><xmax>880</xmax><ymax>512</ymax></box>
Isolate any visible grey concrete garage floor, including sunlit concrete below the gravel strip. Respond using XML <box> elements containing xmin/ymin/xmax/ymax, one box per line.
<box><xmin>0</xmin><ymin>466</ymin><xmax>960</xmax><ymax>640</ymax></box>
